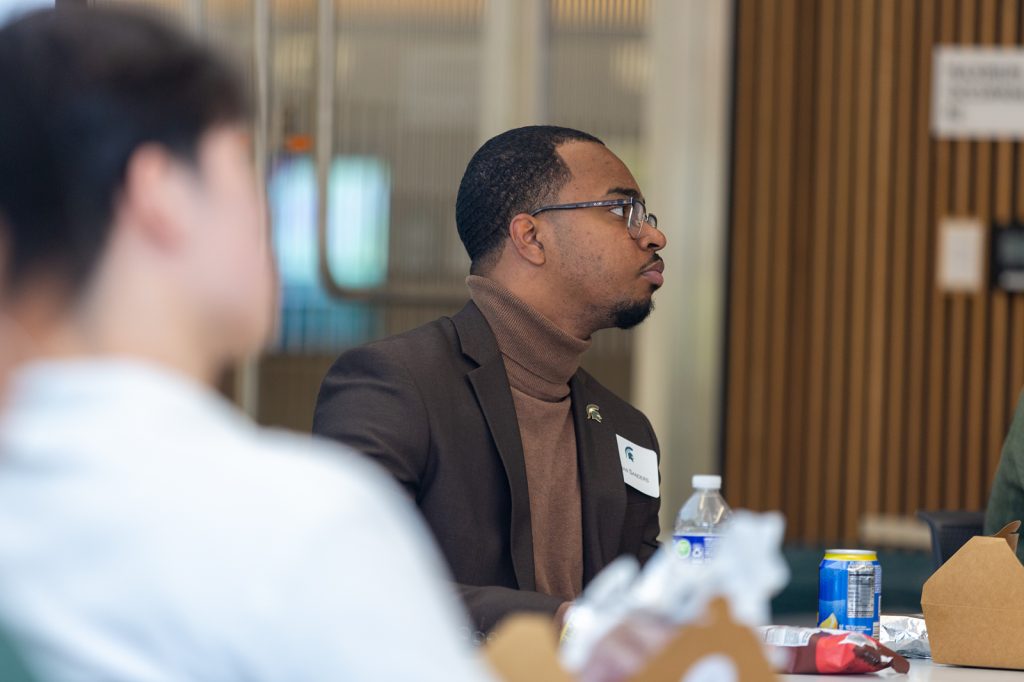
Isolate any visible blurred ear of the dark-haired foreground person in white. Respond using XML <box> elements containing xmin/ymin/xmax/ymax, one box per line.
<box><xmin>116</xmin><ymin>144</ymin><xmax>193</xmax><ymax>249</ymax></box>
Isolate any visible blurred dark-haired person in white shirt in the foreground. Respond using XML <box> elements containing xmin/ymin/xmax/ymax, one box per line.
<box><xmin>0</xmin><ymin>6</ymin><xmax>486</xmax><ymax>682</ymax></box>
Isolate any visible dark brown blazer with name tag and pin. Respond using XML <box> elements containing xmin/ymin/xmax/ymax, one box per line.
<box><xmin>313</xmin><ymin>302</ymin><xmax>660</xmax><ymax>631</ymax></box>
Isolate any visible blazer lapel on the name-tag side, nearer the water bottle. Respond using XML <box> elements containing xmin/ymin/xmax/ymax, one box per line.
<box><xmin>569</xmin><ymin>372</ymin><xmax>626</xmax><ymax>584</ymax></box>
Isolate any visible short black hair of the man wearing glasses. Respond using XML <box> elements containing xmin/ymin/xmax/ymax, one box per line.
<box><xmin>455</xmin><ymin>126</ymin><xmax>604</xmax><ymax>272</ymax></box>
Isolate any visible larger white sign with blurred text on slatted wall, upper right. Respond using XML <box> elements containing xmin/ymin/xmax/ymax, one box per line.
<box><xmin>932</xmin><ymin>46</ymin><xmax>1024</xmax><ymax>139</ymax></box>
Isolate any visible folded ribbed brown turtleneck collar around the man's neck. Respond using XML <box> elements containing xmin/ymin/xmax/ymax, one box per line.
<box><xmin>466</xmin><ymin>274</ymin><xmax>591</xmax><ymax>401</ymax></box>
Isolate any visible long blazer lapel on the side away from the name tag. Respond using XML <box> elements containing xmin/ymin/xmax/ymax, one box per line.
<box><xmin>452</xmin><ymin>302</ymin><xmax>537</xmax><ymax>590</ymax></box>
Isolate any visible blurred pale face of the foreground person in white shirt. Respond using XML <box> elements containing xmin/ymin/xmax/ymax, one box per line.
<box><xmin>182</xmin><ymin>126</ymin><xmax>274</xmax><ymax>358</ymax></box>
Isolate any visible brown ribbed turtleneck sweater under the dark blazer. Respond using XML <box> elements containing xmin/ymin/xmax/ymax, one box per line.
<box><xmin>466</xmin><ymin>274</ymin><xmax>590</xmax><ymax>601</ymax></box>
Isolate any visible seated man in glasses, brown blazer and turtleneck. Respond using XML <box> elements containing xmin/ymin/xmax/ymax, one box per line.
<box><xmin>313</xmin><ymin>126</ymin><xmax>666</xmax><ymax>631</ymax></box>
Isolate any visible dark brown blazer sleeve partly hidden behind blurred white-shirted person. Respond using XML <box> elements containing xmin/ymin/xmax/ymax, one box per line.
<box><xmin>313</xmin><ymin>346</ymin><xmax>562</xmax><ymax>632</ymax></box>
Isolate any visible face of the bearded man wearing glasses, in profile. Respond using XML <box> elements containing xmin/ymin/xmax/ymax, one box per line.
<box><xmin>537</xmin><ymin>141</ymin><xmax>666</xmax><ymax>331</ymax></box>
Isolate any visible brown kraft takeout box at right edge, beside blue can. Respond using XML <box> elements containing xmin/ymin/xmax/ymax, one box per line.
<box><xmin>921</xmin><ymin>521</ymin><xmax>1024</xmax><ymax>670</ymax></box>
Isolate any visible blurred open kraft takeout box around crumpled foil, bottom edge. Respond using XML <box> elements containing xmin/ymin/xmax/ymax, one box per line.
<box><xmin>485</xmin><ymin>599</ymin><xmax>775</xmax><ymax>682</ymax></box>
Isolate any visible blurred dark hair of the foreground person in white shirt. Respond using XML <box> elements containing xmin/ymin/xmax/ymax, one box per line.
<box><xmin>0</xmin><ymin>5</ymin><xmax>249</xmax><ymax>290</ymax></box>
